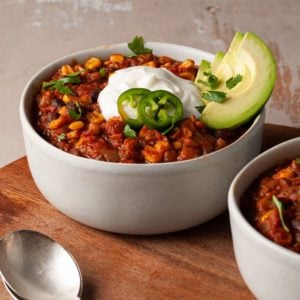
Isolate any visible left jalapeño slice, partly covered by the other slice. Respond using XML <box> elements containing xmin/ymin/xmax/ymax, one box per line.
<box><xmin>118</xmin><ymin>88</ymin><xmax>150</xmax><ymax>128</ymax></box>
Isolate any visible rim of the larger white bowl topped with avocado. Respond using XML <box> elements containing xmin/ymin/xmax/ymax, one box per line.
<box><xmin>19</xmin><ymin>42</ymin><xmax>266</xmax><ymax>170</ymax></box>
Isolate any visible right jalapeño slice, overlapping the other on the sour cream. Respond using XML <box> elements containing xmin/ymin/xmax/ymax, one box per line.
<box><xmin>137</xmin><ymin>90</ymin><xmax>183</xmax><ymax>131</ymax></box>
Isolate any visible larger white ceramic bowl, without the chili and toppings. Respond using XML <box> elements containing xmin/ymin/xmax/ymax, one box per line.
<box><xmin>20</xmin><ymin>43</ymin><xmax>265</xmax><ymax>234</ymax></box>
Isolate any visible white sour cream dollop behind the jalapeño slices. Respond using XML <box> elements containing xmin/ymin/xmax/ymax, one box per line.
<box><xmin>98</xmin><ymin>66</ymin><xmax>201</xmax><ymax>120</ymax></box>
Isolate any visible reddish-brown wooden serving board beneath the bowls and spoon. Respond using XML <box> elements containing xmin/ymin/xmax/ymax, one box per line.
<box><xmin>0</xmin><ymin>124</ymin><xmax>300</xmax><ymax>300</ymax></box>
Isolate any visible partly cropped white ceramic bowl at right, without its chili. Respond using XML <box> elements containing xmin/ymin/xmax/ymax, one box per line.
<box><xmin>228</xmin><ymin>137</ymin><xmax>300</xmax><ymax>300</ymax></box>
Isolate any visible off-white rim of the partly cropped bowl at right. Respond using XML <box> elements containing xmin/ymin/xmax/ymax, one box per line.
<box><xmin>228</xmin><ymin>137</ymin><xmax>300</xmax><ymax>263</ymax></box>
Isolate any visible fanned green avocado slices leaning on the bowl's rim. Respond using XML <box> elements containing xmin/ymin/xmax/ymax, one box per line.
<box><xmin>195</xmin><ymin>32</ymin><xmax>276</xmax><ymax>129</ymax></box>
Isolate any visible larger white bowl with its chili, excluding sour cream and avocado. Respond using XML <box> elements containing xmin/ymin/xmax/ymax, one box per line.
<box><xmin>20</xmin><ymin>38</ymin><xmax>265</xmax><ymax>234</ymax></box>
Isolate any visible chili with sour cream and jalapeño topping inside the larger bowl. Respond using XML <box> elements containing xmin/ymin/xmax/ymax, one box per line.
<box><xmin>34</xmin><ymin>44</ymin><xmax>251</xmax><ymax>163</ymax></box>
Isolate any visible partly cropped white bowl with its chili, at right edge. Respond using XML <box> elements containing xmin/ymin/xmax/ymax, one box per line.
<box><xmin>228</xmin><ymin>137</ymin><xmax>300</xmax><ymax>299</ymax></box>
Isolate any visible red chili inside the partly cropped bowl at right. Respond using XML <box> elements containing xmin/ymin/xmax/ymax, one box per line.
<box><xmin>241</xmin><ymin>158</ymin><xmax>300</xmax><ymax>253</ymax></box>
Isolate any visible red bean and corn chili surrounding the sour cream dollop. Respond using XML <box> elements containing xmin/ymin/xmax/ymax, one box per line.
<box><xmin>34</xmin><ymin>54</ymin><xmax>249</xmax><ymax>163</ymax></box>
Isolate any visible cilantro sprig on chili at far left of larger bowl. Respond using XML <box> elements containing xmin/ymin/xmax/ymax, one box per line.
<box><xmin>42</xmin><ymin>69</ymin><xmax>85</xmax><ymax>95</ymax></box>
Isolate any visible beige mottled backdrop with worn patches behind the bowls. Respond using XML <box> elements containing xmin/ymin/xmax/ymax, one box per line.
<box><xmin>0</xmin><ymin>0</ymin><xmax>300</xmax><ymax>167</ymax></box>
